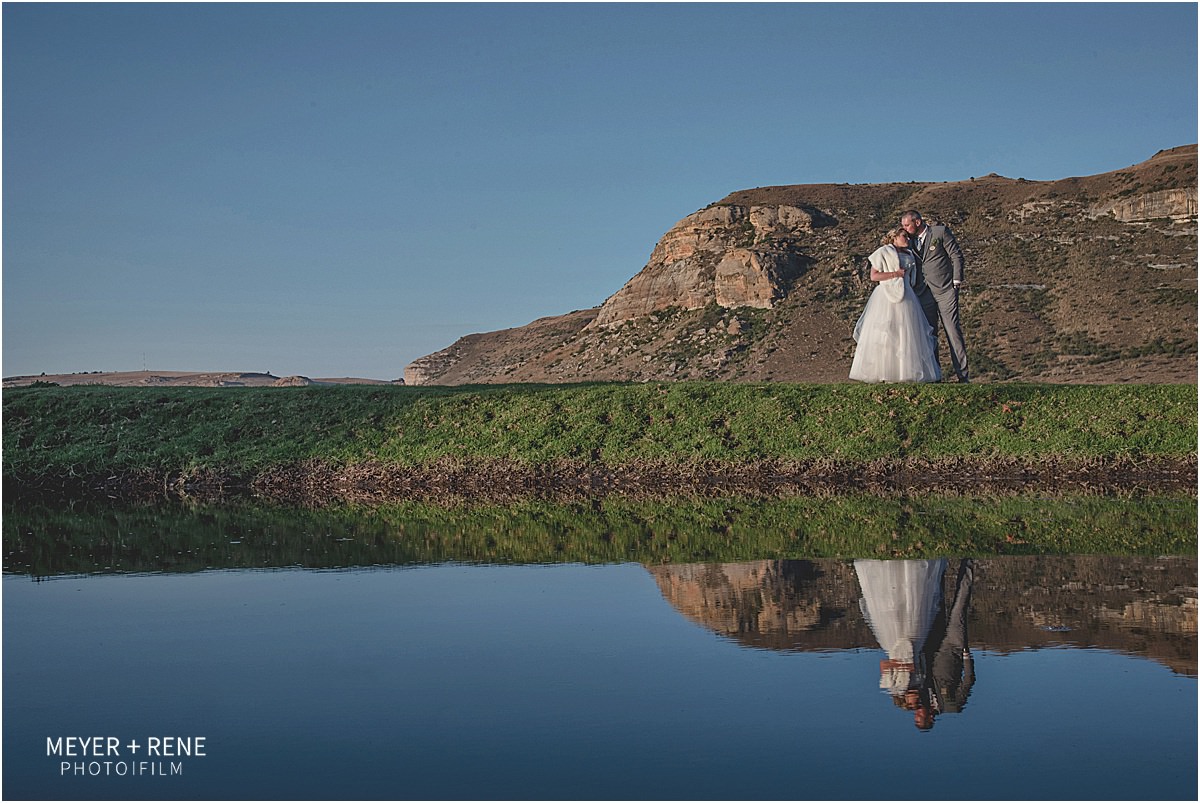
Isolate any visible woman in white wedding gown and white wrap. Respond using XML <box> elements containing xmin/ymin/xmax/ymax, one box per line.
<box><xmin>850</xmin><ymin>228</ymin><xmax>942</xmax><ymax>382</ymax></box>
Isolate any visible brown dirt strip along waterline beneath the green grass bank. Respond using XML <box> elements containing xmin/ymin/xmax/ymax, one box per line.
<box><xmin>4</xmin><ymin>455</ymin><xmax>1196</xmax><ymax>507</ymax></box>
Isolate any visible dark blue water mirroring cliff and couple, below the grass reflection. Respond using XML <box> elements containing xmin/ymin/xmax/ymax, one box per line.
<box><xmin>4</xmin><ymin>496</ymin><xmax>1198</xmax><ymax>799</ymax></box>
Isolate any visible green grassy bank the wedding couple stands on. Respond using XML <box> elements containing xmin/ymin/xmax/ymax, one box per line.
<box><xmin>4</xmin><ymin>383</ymin><xmax>1196</xmax><ymax>490</ymax></box>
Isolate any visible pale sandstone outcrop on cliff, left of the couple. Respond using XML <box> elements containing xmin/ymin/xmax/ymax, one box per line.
<box><xmin>592</xmin><ymin>205</ymin><xmax>833</xmax><ymax>328</ymax></box>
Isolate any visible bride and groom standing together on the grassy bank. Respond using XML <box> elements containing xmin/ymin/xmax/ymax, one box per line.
<box><xmin>850</xmin><ymin>210</ymin><xmax>970</xmax><ymax>382</ymax></box>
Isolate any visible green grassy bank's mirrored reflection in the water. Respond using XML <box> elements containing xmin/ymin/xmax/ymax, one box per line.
<box><xmin>4</xmin><ymin>496</ymin><xmax>1196</xmax><ymax>576</ymax></box>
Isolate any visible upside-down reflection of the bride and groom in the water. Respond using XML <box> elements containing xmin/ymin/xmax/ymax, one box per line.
<box><xmin>854</xmin><ymin>558</ymin><xmax>976</xmax><ymax>730</ymax></box>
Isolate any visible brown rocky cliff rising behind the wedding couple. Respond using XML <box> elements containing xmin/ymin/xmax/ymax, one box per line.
<box><xmin>404</xmin><ymin>145</ymin><xmax>1196</xmax><ymax>384</ymax></box>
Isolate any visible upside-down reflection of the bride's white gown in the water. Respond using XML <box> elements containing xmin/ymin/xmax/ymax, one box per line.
<box><xmin>854</xmin><ymin>558</ymin><xmax>947</xmax><ymax>695</ymax></box>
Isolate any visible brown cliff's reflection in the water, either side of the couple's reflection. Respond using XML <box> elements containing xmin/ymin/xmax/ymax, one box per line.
<box><xmin>648</xmin><ymin>557</ymin><xmax>1196</xmax><ymax>676</ymax></box>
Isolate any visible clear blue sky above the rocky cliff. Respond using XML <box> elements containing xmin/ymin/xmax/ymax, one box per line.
<box><xmin>2</xmin><ymin>2</ymin><xmax>1198</xmax><ymax>379</ymax></box>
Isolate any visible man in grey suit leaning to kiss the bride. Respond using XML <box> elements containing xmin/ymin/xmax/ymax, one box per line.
<box><xmin>900</xmin><ymin>209</ymin><xmax>970</xmax><ymax>382</ymax></box>
